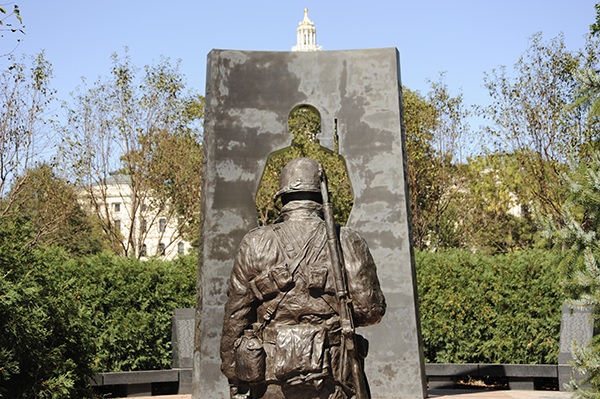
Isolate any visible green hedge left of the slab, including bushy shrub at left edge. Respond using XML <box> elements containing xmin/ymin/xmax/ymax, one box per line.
<box><xmin>0</xmin><ymin>218</ymin><xmax>197</xmax><ymax>399</ymax></box>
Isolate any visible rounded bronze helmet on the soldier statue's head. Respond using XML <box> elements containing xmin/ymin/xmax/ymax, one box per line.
<box><xmin>275</xmin><ymin>158</ymin><xmax>322</xmax><ymax>198</ymax></box>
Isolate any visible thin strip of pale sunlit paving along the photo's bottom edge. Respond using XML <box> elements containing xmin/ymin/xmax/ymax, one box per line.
<box><xmin>125</xmin><ymin>389</ymin><xmax>572</xmax><ymax>399</ymax></box>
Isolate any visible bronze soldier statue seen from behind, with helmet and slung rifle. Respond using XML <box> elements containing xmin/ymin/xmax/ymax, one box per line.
<box><xmin>221</xmin><ymin>158</ymin><xmax>386</xmax><ymax>399</ymax></box>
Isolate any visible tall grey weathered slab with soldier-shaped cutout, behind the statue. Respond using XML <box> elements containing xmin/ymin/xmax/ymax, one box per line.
<box><xmin>193</xmin><ymin>48</ymin><xmax>425</xmax><ymax>399</ymax></box>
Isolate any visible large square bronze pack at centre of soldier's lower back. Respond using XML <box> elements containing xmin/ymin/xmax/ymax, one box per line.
<box><xmin>273</xmin><ymin>324</ymin><xmax>326</xmax><ymax>382</ymax></box>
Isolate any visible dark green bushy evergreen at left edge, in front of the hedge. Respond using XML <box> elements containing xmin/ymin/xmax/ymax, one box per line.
<box><xmin>0</xmin><ymin>215</ymin><xmax>95</xmax><ymax>399</ymax></box>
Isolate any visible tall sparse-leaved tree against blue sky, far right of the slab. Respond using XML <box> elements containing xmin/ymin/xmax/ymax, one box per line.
<box><xmin>482</xmin><ymin>33</ymin><xmax>594</xmax><ymax>220</ymax></box>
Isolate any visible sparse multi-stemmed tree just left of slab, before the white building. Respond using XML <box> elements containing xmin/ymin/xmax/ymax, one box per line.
<box><xmin>62</xmin><ymin>54</ymin><xmax>203</xmax><ymax>257</ymax></box>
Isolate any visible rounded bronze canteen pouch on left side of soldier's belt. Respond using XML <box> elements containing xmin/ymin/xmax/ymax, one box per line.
<box><xmin>234</xmin><ymin>330</ymin><xmax>266</xmax><ymax>382</ymax></box>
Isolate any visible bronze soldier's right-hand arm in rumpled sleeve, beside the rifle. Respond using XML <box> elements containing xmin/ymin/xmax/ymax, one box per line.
<box><xmin>340</xmin><ymin>228</ymin><xmax>386</xmax><ymax>327</ymax></box>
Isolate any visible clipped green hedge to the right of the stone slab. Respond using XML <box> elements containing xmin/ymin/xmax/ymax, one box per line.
<box><xmin>416</xmin><ymin>249</ymin><xmax>563</xmax><ymax>364</ymax></box>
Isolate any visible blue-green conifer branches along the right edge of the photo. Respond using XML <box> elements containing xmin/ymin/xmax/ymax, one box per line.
<box><xmin>545</xmin><ymin>17</ymin><xmax>600</xmax><ymax>399</ymax></box>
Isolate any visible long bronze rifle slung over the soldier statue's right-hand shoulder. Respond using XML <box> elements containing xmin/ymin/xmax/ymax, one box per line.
<box><xmin>319</xmin><ymin>165</ymin><xmax>370</xmax><ymax>399</ymax></box>
